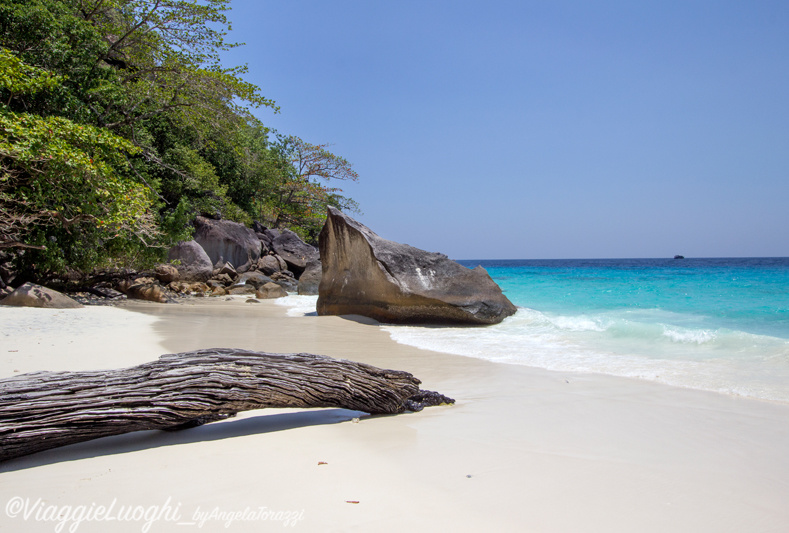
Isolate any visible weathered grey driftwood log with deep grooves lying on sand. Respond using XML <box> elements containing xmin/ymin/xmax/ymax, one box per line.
<box><xmin>0</xmin><ymin>349</ymin><xmax>454</xmax><ymax>461</ymax></box>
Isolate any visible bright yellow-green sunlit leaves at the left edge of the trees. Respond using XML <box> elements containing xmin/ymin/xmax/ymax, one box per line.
<box><xmin>0</xmin><ymin>49</ymin><xmax>155</xmax><ymax>269</ymax></box>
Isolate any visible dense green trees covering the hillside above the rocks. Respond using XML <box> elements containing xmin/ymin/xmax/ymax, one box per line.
<box><xmin>0</xmin><ymin>0</ymin><xmax>358</xmax><ymax>276</ymax></box>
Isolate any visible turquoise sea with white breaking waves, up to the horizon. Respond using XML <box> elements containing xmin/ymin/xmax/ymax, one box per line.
<box><xmin>278</xmin><ymin>258</ymin><xmax>789</xmax><ymax>402</ymax></box>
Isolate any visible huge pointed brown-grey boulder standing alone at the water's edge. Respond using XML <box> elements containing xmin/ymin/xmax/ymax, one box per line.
<box><xmin>317</xmin><ymin>207</ymin><xmax>516</xmax><ymax>324</ymax></box>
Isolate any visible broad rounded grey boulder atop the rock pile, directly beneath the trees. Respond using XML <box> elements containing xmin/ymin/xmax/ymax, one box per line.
<box><xmin>195</xmin><ymin>217</ymin><xmax>261</xmax><ymax>273</ymax></box>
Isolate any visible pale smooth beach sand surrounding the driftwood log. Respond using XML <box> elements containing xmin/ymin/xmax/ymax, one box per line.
<box><xmin>0</xmin><ymin>299</ymin><xmax>789</xmax><ymax>533</ymax></box>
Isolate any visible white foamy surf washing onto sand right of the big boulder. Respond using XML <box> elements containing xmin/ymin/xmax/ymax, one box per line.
<box><xmin>384</xmin><ymin>308</ymin><xmax>789</xmax><ymax>402</ymax></box>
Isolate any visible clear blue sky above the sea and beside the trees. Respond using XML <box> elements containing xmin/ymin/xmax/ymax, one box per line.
<box><xmin>220</xmin><ymin>0</ymin><xmax>789</xmax><ymax>259</ymax></box>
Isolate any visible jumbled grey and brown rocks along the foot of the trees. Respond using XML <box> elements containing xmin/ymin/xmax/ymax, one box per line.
<box><xmin>0</xmin><ymin>217</ymin><xmax>321</xmax><ymax>307</ymax></box>
